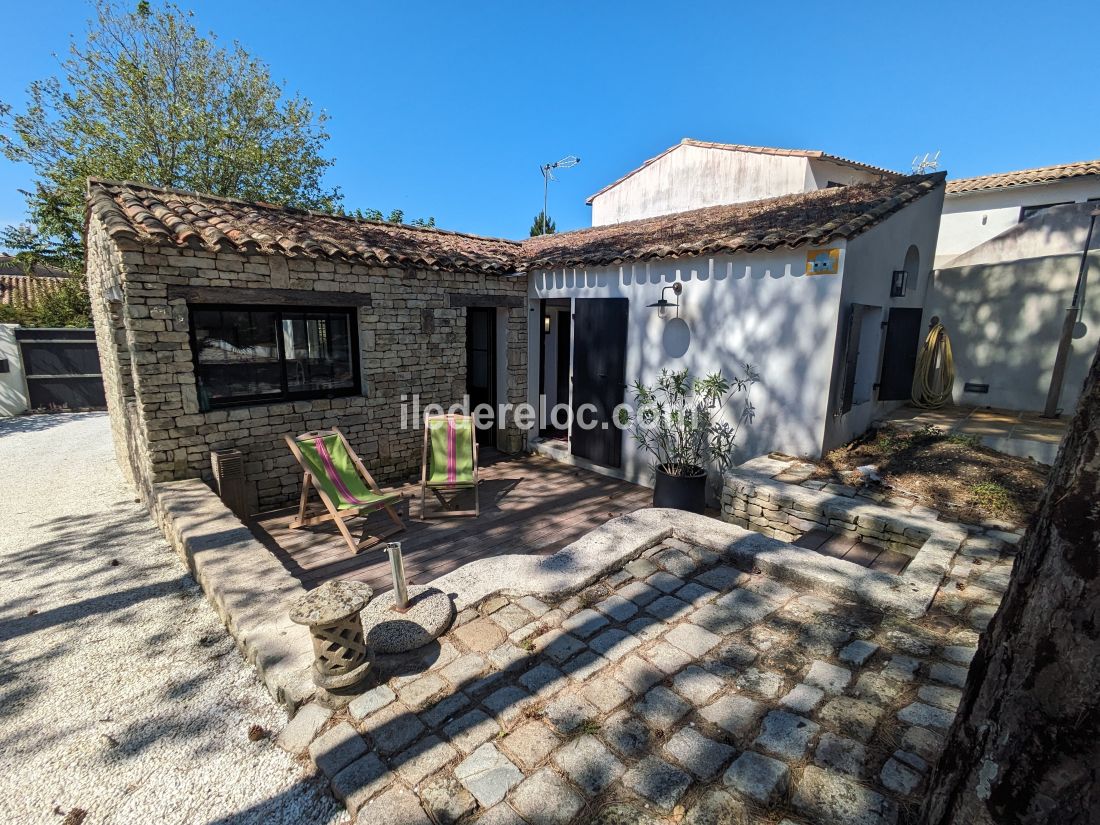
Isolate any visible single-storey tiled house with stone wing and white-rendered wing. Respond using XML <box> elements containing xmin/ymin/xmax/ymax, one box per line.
<box><xmin>87</xmin><ymin>169</ymin><xmax>944</xmax><ymax>509</ymax></box>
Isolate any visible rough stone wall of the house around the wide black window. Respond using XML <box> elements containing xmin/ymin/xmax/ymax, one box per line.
<box><xmin>88</xmin><ymin>217</ymin><xmax>527</xmax><ymax>509</ymax></box>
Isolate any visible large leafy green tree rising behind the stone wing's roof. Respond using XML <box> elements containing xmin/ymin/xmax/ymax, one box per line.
<box><xmin>0</xmin><ymin>0</ymin><xmax>341</xmax><ymax>271</ymax></box>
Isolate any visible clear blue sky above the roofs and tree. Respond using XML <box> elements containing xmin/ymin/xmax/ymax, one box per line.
<box><xmin>0</xmin><ymin>0</ymin><xmax>1100</xmax><ymax>238</ymax></box>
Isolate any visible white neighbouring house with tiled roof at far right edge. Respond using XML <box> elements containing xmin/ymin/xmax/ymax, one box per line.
<box><xmin>935</xmin><ymin>160</ymin><xmax>1100</xmax><ymax>268</ymax></box>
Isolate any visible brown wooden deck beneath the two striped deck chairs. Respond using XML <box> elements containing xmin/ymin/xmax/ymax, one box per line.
<box><xmin>251</xmin><ymin>450</ymin><xmax>652</xmax><ymax>593</ymax></box>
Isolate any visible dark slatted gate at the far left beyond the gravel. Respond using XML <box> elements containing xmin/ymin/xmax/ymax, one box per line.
<box><xmin>15</xmin><ymin>328</ymin><xmax>107</xmax><ymax>409</ymax></box>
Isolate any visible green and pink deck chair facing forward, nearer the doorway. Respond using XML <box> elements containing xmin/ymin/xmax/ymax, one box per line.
<box><xmin>420</xmin><ymin>415</ymin><xmax>481</xmax><ymax>519</ymax></box>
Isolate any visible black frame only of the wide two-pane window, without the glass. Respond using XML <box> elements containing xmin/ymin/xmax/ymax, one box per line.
<box><xmin>187</xmin><ymin>304</ymin><xmax>362</xmax><ymax>413</ymax></box>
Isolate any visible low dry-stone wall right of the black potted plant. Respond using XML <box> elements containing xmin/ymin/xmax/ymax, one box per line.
<box><xmin>722</xmin><ymin>459</ymin><xmax>932</xmax><ymax>557</ymax></box>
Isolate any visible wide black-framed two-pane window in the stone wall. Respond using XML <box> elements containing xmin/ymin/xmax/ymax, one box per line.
<box><xmin>190</xmin><ymin>306</ymin><xmax>359</xmax><ymax>410</ymax></box>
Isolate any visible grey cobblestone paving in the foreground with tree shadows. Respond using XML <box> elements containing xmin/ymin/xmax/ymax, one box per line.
<box><xmin>292</xmin><ymin>525</ymin><xmax>1012</xmax><ymax>825</ymax></box>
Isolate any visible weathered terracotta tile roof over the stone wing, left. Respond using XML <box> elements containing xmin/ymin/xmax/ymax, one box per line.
<box><xmin>88</xmin><ymin>179</ymin><xmax>519</xmax><ymax>274</ymax></box>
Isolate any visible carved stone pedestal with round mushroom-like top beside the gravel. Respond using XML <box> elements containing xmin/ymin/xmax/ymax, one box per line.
<box><xmin>290</xmin><ymin>581</ymin><xmax>374</xmax><ymax>690</ymax></box>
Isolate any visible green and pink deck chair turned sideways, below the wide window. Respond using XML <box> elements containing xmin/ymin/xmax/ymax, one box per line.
<box><xmin>286</xmin><ymin>427</ymin><xmax>405</xmax><ymax>553</ymax></box>
